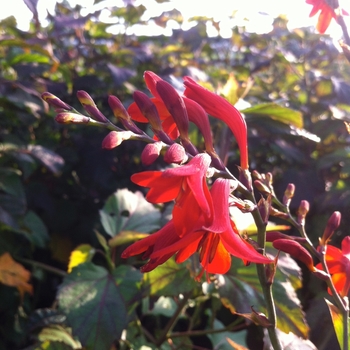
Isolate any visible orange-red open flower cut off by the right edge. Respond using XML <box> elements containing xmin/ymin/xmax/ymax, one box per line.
<box><xmin>316</xmin><ymin>236</ymin><xmax>350</xmax><ymax>297</ymax></box>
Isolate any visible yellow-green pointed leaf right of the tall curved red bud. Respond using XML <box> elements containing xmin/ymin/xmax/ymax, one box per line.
<box><xmin>240</xmin><ymin>103</ymin><xmax>303</xmax><ymax>129</ymax></box>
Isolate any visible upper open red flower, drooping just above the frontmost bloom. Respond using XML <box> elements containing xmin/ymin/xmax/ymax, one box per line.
<box><xmin>131</xmin><ymin>153</ymin><xmax>211</xmax><ymax>217</ymax></box>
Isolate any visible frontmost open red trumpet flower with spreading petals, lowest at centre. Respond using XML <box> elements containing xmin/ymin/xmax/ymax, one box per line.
<box><xmin>150</xmin><ymin>179</ymin><xmax>271</xmax><ymax>278</ymax></box>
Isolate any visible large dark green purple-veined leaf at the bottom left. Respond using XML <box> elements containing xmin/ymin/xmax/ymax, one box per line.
<box><xmin>58</xmin><ymin>262</ymin><xmax>127</xmax><ymax>349</ymax></box>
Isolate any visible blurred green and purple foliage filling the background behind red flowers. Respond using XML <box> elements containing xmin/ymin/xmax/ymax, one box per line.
<box><xmin>0</xmin><ymin>1</ymin><xmax>350</xmax><ymax>349</ymax></box>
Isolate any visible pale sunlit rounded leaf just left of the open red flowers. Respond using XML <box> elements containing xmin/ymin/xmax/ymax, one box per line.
<box><xmin>100</xmin><ymin>189</ymin><xmax>161</xmax><ymax>237</ymax></box>
